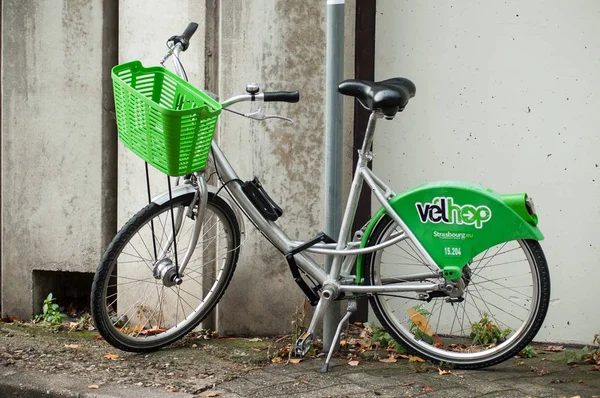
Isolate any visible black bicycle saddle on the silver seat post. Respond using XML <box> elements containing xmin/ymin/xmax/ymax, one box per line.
<box><xmin>338</xmin><ymin>77</ymin><xmax>416</xmax><ymax>119</ymax></box>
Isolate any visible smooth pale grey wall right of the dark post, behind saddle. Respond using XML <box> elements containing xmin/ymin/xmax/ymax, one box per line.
<box><xmin>374</xmin><ymin>0</ymin><xmax>600</xmax><ymax>344</ymax></box>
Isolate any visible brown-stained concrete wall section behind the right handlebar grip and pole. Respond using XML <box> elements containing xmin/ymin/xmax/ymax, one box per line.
<box><xmin>218</xmin><ymin>0</ymin><xmax>354</xmax><ymax>334</ymax></box>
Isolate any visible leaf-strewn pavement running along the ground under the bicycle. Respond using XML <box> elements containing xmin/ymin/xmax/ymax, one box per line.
<box><xmin>0</xmin><ymin>322</ymin><xmax>600</xmax><ymax>398</ymax></box>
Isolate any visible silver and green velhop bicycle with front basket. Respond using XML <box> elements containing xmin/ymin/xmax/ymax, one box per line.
<box><xmin>91</xmin><ymin>24</ymin><xmax>550</xmax><ymax>371</ymax></box>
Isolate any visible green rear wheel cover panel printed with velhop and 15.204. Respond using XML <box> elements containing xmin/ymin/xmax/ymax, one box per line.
<box><xmin>356</xmin><ymin>181</ymin><xmax>544</xmax><ymax>283</ymax></box>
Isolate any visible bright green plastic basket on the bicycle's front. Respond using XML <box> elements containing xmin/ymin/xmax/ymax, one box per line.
<box><xmin>112</xmin><ymin>61</ymin><xmax>221</xmax><ymax>176</ymax></box>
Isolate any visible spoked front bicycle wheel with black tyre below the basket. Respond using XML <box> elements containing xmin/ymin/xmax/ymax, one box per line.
<box><xmin>91</xmin><ymin>193</ymin><xmax>240</xmax><ymax>352</ymax></box>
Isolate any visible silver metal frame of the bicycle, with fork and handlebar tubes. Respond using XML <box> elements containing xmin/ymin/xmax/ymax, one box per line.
<box><xmin>159</xmin><ymin>44</ymin><xmax>441</xmax><ymax>293</ymax></box>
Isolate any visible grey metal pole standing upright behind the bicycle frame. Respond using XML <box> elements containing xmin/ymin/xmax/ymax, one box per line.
<box><xmin>323</xmin><ymin>0</ymin><xmax>345</xmax><ymax>351</ymax></box>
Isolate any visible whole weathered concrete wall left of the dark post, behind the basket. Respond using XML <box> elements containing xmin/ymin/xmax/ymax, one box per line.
<box><xmin>2</xmin><ymin>0</ymin><xmax>354</xmax><ymax>334</ymax></box>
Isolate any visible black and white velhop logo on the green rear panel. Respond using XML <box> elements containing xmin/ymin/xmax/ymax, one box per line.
<box><xmin>416</xmin><ymin>197</ymin><xmax>492</xmax><ymax>229</ymax></box>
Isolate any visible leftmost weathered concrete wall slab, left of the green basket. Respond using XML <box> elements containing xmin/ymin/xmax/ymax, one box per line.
<box><xmin>1</xmin><ymin>0</ymin><xmax>114</xmax><ymax>317</ymax></box>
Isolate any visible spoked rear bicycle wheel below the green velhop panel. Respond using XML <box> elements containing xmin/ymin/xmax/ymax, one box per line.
<box><xmin>366</xmin><ymin>216</ymin><xmax>550</xmax><ymax>369</ymax></box>
